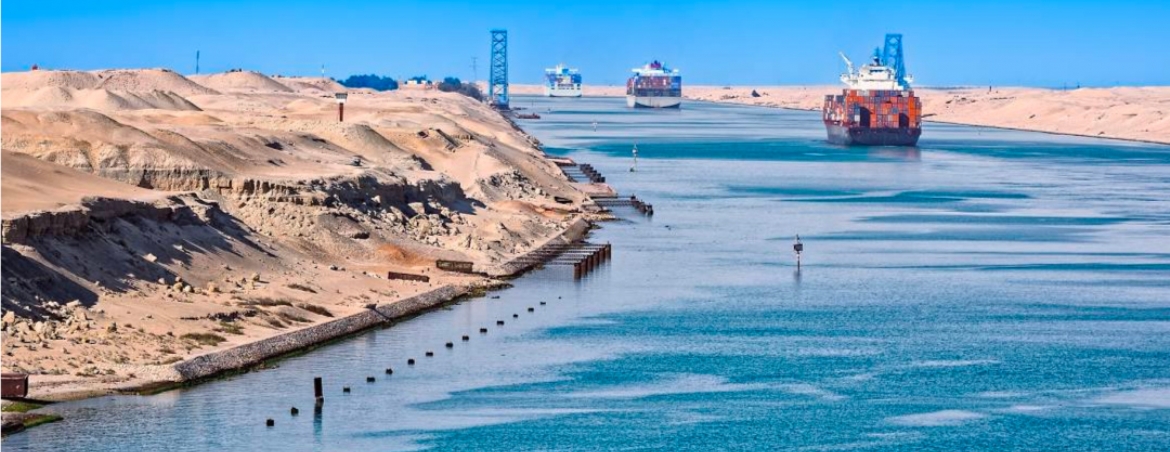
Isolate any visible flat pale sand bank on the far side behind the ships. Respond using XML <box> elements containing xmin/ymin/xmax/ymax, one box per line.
<box><xmin>510</xmin><ymin>84</ymin><xmax>1170</xmax><ymax>144</ymax></box>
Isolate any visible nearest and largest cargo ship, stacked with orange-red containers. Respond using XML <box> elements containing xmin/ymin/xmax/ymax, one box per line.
<box><xmin>821</xmin><ymin>47</ymin><xmax>922</xmax><ymax>146</ymax></box>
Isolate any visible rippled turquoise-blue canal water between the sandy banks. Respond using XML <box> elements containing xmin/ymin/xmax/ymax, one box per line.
<box><xmin>4</xmin><ymin>98</ymin><xmax>1170</xmax><ymax>451</ymax></box>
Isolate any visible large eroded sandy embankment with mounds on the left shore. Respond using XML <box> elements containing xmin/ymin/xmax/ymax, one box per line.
<box><xmin>0</xmin><ymin>69</ymin><xmax>587</xmax><ymax>399</ymax></box>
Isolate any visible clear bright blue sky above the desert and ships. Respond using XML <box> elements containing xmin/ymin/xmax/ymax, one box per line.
<box><xmin>0</xmin><ymin>0</ymin><xmax>1170</xmax><ymax>87</ymax></box>
